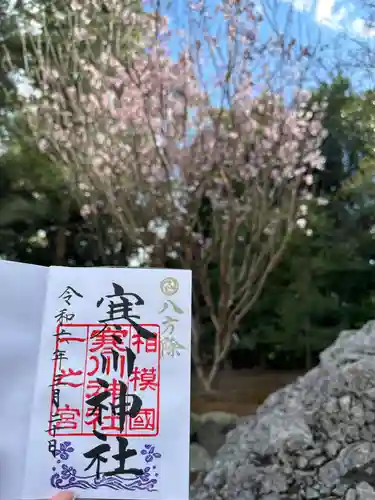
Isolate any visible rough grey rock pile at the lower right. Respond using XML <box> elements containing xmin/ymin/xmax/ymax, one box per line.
<box><xmin>191</xmin><ymin>321</ymin><xmax>375</xmax><ymax>500</ymax></box>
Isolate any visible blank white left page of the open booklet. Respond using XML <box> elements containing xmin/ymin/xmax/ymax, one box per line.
<box><xmin>0</xmin><ymin>260</ymin><xmax>48</xmax><ymax>500</ymax></box>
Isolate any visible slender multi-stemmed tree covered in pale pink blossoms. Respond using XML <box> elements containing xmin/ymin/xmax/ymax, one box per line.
<box><xmin>9</xmin><ymin>0</ymin><xmax>325</xmax><ymax>391</ymax></box>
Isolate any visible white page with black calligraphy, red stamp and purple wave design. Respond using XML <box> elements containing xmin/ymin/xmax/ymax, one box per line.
<box><xmin>22</xmin><ymin>267</ymin><xmax>191</xmax><ymax>500</ymax></box>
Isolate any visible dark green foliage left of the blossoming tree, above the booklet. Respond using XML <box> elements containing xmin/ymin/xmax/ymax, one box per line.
<box><xmin>0</xmin><ymin>0</ymin><xmax>138</xmax><ymax>266</ymax></box>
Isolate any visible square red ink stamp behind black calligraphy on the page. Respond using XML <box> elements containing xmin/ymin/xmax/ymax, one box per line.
<box><xmin>48</xmin><ymin>324</ymin><xmax>160</xmax><ymax>437</ymax></box>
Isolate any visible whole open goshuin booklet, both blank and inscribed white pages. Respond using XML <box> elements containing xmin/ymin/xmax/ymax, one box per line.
<box><xmin>0</xmin><ymin>261</ymin><xmax>191</xmax><ymax>500</ymax></box>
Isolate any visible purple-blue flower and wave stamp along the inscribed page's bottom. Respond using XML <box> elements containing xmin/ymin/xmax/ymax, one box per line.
<box><xmin>51</xmin><ymin>441</ymin><xmax>161</xmax><ymax>491</ymax></box>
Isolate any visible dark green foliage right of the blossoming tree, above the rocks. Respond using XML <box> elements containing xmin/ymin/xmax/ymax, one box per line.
<box><xmin>232</xmin><ymin>77</ymin><xmax>375</xmax><ymax>368</ymax></box>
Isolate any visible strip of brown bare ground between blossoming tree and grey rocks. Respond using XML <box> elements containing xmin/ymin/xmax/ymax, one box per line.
<box><xmin>191</xmin><ymin>370</ymin><xmax>303</xmax><ymax>416</ymax></box>
